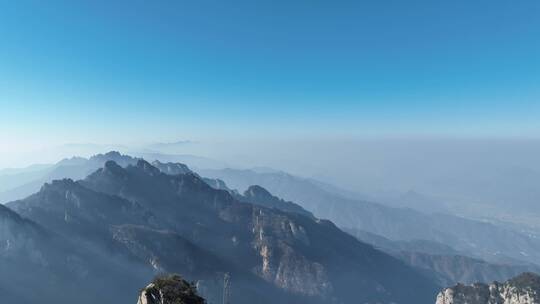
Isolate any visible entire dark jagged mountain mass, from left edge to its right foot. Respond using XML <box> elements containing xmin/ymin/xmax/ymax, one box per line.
<box><xmin>0</xmin><ymin>153</ymin><xmax>437</xmax><ymax>304</ymax></box>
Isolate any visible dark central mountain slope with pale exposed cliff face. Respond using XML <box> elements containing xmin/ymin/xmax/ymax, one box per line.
<box><xmin>81</xmin><ymin>161</ymin><xmax>440</xmax><ymax>303</ymax></box>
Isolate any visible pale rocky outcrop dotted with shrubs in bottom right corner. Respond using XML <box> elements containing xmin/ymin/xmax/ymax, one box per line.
<box><xmin>436</xmin><ymin>273</ymin><xmax>540</xmax><ymax>304</ymax></box>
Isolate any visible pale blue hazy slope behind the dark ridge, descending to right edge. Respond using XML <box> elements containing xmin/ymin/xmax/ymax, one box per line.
<box><xmin>199</xmin><ymin>169</ymin><xmax>540</xmax><ymax>264</ymax></box>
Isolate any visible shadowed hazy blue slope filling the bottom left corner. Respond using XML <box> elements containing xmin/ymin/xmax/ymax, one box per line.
<box><xmin>0</xmin><ymin>200</ymin><xmax>152</xmax><ymax>304</ymax></box>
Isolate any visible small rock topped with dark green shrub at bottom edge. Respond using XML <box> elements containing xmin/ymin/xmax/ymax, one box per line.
<box><xmin>137</xmin><ymin>275</ymin><xmax>206</xmax><ymax>304</ymax></box>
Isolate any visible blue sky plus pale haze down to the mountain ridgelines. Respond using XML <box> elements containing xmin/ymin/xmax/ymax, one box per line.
<box><xmin>0</xmin><ymin>0</ymin><xmax>540</xmax><ymax>228</ymax></box>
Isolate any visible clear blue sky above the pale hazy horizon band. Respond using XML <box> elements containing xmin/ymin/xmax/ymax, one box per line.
<box><xmin>0</xmin><ymin>0</ymin><xmax>540</xmax><ymax>145</ymax></box>
